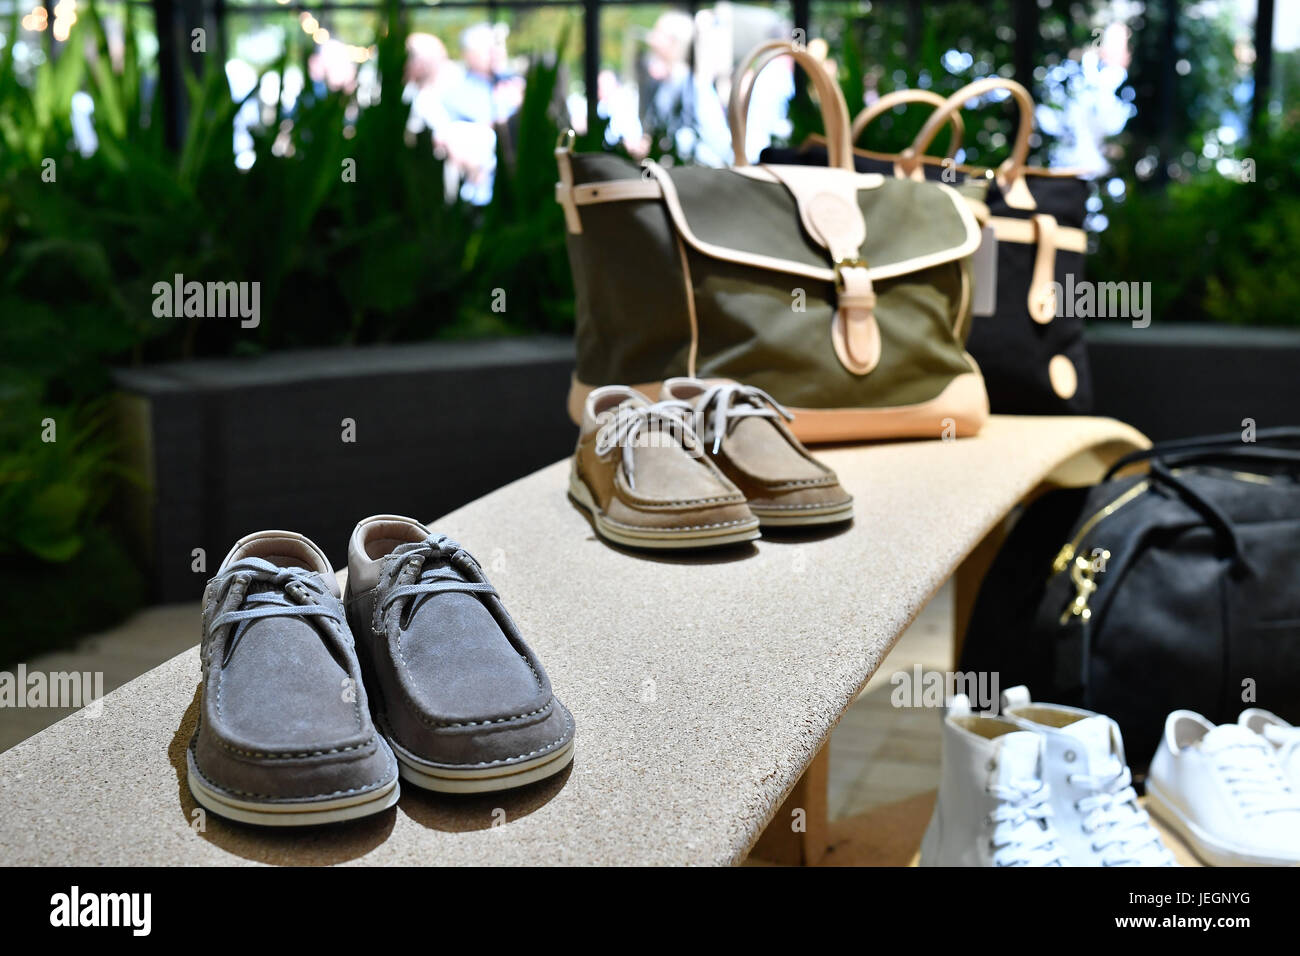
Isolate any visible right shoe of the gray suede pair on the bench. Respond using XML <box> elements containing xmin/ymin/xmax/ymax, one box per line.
<box><xmin>345</xmin><ymin>515</ymin><xmax>573</xmax><ymax>793</ymax></box>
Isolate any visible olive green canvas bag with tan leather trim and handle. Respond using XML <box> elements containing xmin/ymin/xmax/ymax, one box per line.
<box><xmin>556</xmin><ymin>40</ymin><xmax>988</xmax><ymax>441</ymax></box>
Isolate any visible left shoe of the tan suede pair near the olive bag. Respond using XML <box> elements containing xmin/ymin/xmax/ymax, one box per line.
<box><xmin>569</xmin><ymin>385</ymin><xmax>758</xmax><ymax>549</ymax></box>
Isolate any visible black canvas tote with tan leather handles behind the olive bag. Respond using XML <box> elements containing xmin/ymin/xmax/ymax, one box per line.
<box><xmin>762</xmin><ymin>77</ymin><xmax>1092</xmax><ymax>415</ymax></box>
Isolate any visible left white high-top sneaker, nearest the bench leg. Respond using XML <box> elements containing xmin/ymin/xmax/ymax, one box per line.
<box><xmin>920</xmin><ymin>695</ymin><xmax>1066</xmax><ymax>866</ymax></box>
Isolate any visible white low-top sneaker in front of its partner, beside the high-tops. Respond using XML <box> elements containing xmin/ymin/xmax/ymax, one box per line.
<box><xmin>1147</xmin><ymin>710</ymin><xmax>1300</xmax><ymax>866</ymax></box>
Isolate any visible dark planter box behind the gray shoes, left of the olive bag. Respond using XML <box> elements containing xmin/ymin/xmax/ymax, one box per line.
<box><xmin>116</xmin><ymin>337</ymin><xmax>576</xmax><ymax>602</ymax></box>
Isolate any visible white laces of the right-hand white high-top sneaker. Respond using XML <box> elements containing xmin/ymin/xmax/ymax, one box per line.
<box><xmin>1066</xmin><ymin>760</ymin><xmax>1174</xmax><ymax>866</ymax></box>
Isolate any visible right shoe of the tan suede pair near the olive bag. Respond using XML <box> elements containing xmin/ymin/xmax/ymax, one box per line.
<box><xmin>660</xmin><ymin>378</ymin><xmax>853</xmax><ymax>528</ymax></box>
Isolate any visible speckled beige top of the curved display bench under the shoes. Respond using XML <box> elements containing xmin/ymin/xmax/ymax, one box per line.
<box><xmin>0</xmin><ymin>418</ymin><xmax>1144</xmax><ymax>865</ymax></box>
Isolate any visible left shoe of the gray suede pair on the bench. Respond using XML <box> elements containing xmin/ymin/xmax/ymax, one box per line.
<box><xmin>187</xmin><ymin>531</ymin><xmax>399</xmax><ymax>826</ymax></box>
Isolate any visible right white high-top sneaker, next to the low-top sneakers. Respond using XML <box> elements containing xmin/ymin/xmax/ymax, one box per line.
<box><xmin>1002</xmin><ymin>687</ymin><xmax>1178</xmax><ymax>866</ymax></box>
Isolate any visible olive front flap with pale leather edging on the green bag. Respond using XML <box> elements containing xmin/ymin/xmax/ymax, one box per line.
<box><xmin>646</xmin><ymin>163</ymin><xmax>980</xmax><ymax>281</ymax></box>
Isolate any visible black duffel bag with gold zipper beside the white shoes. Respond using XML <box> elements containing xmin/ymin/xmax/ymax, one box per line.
<box><xmin>959</xmin><ymin>428</ymin><xmax>1300</xmax><ymax>771</ymax></box>
